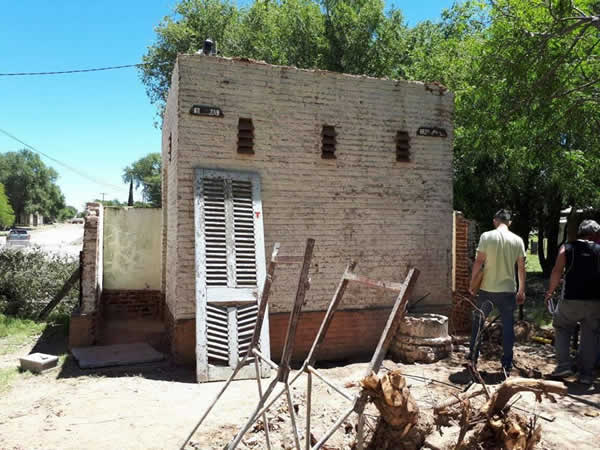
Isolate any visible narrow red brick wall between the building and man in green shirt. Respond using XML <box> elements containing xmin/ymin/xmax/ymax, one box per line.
<box><xmin>449</xmin><ymin>212</ymin><xmax>479</xmax><ymax>333</ymax></box>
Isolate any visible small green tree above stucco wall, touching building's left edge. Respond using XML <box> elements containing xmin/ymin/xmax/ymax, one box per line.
<box><xmin>123</xmin><ymin>153</ymin><xmax>162</xmax><ymax>208</ymax></box>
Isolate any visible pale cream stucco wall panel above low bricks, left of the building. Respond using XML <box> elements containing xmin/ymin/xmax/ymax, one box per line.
<box><xmin>104</xmin><ymin>208</ymin><xmax>162</xmax><ymax>290</ymax></box>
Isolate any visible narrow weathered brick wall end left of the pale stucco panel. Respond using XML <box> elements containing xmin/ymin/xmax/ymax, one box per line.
<box><xmin>81</xmin><ymin>203</ymin><xmax>104</xmax><ymax>314</ymax></box>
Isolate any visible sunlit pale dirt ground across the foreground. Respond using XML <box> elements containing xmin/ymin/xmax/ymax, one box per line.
<box><xmin>0</xmin><ymin>329</ymin><xmax>600</xmax><ymax>450</ymax></box>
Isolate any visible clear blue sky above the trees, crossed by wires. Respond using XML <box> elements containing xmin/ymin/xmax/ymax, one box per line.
<box><xmin>0</xmin><ymin>0</ymin><xmax>453</xmax><ymax>210</ymax></box>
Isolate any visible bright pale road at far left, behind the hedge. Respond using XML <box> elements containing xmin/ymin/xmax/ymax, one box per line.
<box><xmin>0</xmin><ymin>224</ymin><xmax>83</xmax><ymax>257</ymax></box>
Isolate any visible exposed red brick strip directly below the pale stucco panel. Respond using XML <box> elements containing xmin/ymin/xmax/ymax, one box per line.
<box><xmin>102</xmin><ymin>289</ymin><xmax>164</xmax><ymax>319</ymax></box>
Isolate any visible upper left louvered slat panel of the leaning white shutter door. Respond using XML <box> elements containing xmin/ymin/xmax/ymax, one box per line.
<box><xmin>202</xmin><ymin>178</ymin><xmax>227</xmax><ymax>286</ymax></box>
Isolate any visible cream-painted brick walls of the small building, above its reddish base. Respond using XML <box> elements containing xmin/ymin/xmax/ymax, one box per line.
<box><xmin>163</xmin><ymin>55</ymin><xmax>453</xmax><ymax>322</ymax></box>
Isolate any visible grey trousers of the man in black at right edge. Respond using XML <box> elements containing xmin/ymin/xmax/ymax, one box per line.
<box><xmin>552</xmin><ymin>299</ymin><xmax>600</xmax><ymax>376</ymax></box>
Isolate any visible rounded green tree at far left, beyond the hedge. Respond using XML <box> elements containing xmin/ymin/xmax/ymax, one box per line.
<box><xmin>0</xmin><ymin>150</ymin><xmax>65</xmax><ymax>222</ymax></box>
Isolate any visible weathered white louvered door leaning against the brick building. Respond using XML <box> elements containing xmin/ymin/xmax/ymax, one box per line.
<box><xmin>195</xmin><ymin>169</ymin><xmax>269</xmax><ymax>381</ymax></box>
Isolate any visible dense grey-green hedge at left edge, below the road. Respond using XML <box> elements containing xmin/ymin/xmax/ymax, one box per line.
<box><xmin>0</xmin><ymin>247</ymin><xmax>79</xmax><ymax>318</ymax></box>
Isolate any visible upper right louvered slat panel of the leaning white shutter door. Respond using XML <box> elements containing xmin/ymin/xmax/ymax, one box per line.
<box><xmin>231</xmin><ymin>180</ymin><xmax>257</xmax><ymax>287</ymax></box>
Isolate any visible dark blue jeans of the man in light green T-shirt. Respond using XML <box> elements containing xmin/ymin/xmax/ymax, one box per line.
<box><xmin>470</xmin><ymin>291</ymin><xmax>517</xmax><ymax>369</ymax></box>
